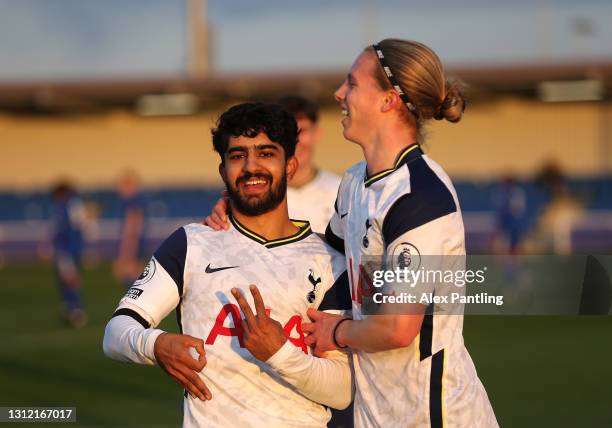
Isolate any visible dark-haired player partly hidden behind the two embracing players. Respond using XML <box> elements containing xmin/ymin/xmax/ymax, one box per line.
<box><xmin>278</xmin><ymin>95</ymin><xmax>340</xmax><ymax>233</ymax></box>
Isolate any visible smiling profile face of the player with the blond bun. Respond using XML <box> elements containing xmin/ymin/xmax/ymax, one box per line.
<box><xmin>334</xmin><ymin>51</ymin><xmax>385</xmax><ymax>144</ymax></box>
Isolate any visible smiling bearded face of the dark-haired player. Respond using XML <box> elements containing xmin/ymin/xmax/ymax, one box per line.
<box><xmin>219</xmin><ymin>132</ymin><xmax>297</xmax><ymax>216</ymax></box>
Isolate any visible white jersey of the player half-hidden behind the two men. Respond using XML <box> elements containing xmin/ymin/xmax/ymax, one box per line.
<box><xmin>287</xmin><ymin>170</ymin><xmax>340</xmax><ymax>233</ymax></box>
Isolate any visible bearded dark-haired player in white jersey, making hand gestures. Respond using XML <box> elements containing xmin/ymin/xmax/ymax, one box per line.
<box><xmin>104</xmin><ymin>103</ymin><xmax>352</xmax><ymax>427</ymax></box>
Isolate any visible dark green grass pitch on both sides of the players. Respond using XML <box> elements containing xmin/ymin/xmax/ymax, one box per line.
<box><xmin>0</xmin><ymin>265</ymin><xmax>612</xmax><ymax>427</ymax></box>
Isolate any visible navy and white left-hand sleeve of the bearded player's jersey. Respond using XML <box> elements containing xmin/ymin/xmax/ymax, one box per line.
<box><xmin>113</xmin><ymin>228</ymin><xmax>187</xmax><ymax>328</ymax></box>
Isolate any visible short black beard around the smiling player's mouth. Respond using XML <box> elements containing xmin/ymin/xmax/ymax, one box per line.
<box><xmin>225</xmin><ymin>173</ymin><xmax>287</xmax><ymax>217</ymax></box>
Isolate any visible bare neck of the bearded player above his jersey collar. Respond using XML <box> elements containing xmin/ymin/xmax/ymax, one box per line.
<box><xmin>232</xmin><ymin>199</ymin><xmax>299</xmax><ymax>241</ymax></box>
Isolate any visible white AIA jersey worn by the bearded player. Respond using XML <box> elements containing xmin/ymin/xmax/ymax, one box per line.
<box><xmin>115</xmin><ymin>218</ymin><xmax>350</xmax><ymax>428</ymax></box>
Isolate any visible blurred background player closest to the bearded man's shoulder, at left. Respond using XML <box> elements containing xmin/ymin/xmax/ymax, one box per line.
<box><xmin>113</xmin><ymin>171</ymin><xmax>145</xmax><ymax>288</ymax></box>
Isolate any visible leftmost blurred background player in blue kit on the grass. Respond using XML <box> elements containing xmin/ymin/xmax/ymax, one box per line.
<box><xmin>51</xmin><ymin>181</ymin><xmax>87</xmax><ymax>327</ymax></box>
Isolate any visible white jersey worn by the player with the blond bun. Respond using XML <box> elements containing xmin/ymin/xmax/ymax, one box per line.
<box><xmin>326</xmin><ymin>145</ymin><xmax>497</xmax><ymax>428</ymax></box>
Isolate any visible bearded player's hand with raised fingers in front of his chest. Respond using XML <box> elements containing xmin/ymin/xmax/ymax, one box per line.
<box><xmin>232</xmin><ymin>284</ymin><xmax>287</xmax><ymax>361</ymax></box>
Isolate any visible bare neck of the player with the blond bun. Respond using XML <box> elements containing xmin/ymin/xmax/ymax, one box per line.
<box><xmin>361</xmin><ymin>126</ymin><xmax>416</xmax><ymax>177</ymax></box>
